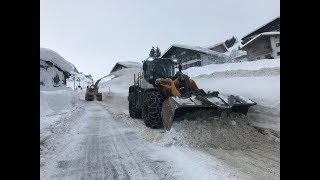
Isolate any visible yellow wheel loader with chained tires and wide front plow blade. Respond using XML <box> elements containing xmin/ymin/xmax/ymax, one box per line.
<box><xmin>128</xmin><ymin>58</ymin><xmax>257</xmax><ymax>130</ymax></box>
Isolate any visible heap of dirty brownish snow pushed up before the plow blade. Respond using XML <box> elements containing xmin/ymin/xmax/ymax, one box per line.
<box><xmin>160</xmin><ymin>111</ymin><xmax>278</xmax><ymax>150</ymax></box>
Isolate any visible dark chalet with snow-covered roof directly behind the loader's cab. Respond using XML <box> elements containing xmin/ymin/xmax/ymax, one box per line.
<box><xmin>161</xmin><ymin>44</ymin><xmax>229</xmax><ymax>69</ymax></box>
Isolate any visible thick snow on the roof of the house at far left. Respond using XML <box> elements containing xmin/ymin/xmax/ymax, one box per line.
<box><xmin>40</xmin><ymin>48</ymin><xmax>74</xmax><ymax>73</ymax></box>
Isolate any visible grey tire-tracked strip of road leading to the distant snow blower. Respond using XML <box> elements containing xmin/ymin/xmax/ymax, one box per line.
<box><xmin>41</xmin><ymin>102</ymin><xmax>176</xmax><ymax>179</ymax></box>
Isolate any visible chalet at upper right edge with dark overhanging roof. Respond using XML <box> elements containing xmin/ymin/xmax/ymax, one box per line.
<box><xmin>240</xmin><ymin>17</ymin><xmax>280</xmax><ymax>61</ymax></box>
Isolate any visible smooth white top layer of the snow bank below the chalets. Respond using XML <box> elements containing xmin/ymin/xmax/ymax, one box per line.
<box><xmin>182</xmin><ymin>59</ymin><xmax>280</xmax><ymax>77</ymax></box>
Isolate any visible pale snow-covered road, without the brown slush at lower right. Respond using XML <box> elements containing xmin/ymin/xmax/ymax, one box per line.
<box><xmin>40</xmin><ymin>101</ymin><xmax>248</xmax><ymax>179</ymax></box>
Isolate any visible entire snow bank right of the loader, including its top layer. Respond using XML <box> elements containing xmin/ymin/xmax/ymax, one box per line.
<box><xmin>185</xmin><ymin>59</ymin><xmax>280</xmax><ymax>131</ymax></box>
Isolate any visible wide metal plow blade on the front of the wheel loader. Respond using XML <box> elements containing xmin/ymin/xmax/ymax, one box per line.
<box><xmin>162</xmin><ymin>95</ymin><xmax>257</xmax><ymax>131</ymax></box>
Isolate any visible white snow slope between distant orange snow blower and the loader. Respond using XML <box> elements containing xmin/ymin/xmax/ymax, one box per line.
<box><xmin>99</xmin><ymin>68</ymin><xmax>142</xmax><ymax>97</ymax></box>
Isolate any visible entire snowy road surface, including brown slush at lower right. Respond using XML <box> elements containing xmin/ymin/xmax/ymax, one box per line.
<box><xmin>40</xmin><ymin>98</ymin><xmax>279</xmax><ymax>180</ymax></box>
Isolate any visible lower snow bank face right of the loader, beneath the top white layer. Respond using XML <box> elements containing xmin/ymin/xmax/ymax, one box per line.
<box><xmin>193</xmin><ymin>68</ymin><xmax>280</xmax><ymax>131</ymax></box>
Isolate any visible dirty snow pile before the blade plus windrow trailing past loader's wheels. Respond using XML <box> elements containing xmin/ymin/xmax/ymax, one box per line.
<box><xmin>103</xmin><ymin>98</ymin><xmax>280</xmax><ymax>150</ymax></box>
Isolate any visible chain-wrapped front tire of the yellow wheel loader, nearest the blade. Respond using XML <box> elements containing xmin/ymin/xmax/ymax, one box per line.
<box><xmin>142</xmin><ymin>91</ymin><xmax>164</xmax><ymax>129</ymax></box>
